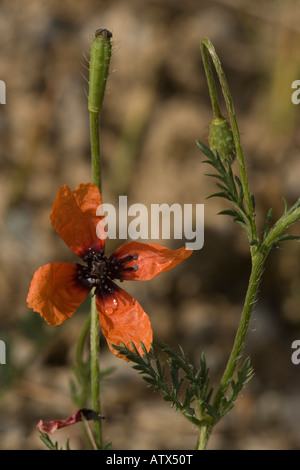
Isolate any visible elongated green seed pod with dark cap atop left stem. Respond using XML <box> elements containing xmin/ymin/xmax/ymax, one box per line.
<box><xmin>88</xmin><ymin>29</ymin><xmax>112</xmax><ymax>114</ymax></box>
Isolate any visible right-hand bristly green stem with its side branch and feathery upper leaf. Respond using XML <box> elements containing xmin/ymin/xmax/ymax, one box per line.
<box><xmin>197</xmin><ymin>38</ymin><xmax>300</xmax><ymax>450</ymax></box>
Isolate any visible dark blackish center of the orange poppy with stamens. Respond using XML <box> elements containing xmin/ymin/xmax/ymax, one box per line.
<box><xmin>77</xmin><ymin>248</ymin><xmax>138</xmax><ymax>294</ymax></box>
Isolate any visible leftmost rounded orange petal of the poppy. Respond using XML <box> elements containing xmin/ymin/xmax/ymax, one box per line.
<box><xmin>27</xmin><ymin>263</ymin><xmax>90</xmax><ymax>325</ymax></box>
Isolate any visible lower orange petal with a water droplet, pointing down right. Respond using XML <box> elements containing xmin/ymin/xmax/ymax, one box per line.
<box><xmin>96</xmin><ymin>284</ymin><xmax>153</xmax><ymax>360</ymax></box>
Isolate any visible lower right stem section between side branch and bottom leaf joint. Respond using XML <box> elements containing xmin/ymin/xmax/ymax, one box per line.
<box><xmin>214</xmin><ymin>251</ymin><xmax>266</xmax><ymax>410</ymax></box>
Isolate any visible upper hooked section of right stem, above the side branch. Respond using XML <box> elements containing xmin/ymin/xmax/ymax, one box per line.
<box><xmin>200</xmin><ymin>38</ymin><xmax>257</xmax><ymax>241</ymax></box>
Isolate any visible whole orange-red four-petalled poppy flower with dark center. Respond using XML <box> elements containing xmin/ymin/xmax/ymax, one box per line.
<box><xmin>27</xmin><ymin>183</ymin><xmax>192</xmax><ymax>357</ymax></box>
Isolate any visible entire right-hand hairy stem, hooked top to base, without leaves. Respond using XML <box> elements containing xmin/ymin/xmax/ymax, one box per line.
<box><xmin>197</xmin><ymin>39</ymin><xmax>300</xmax><ymax>450</ymax></box>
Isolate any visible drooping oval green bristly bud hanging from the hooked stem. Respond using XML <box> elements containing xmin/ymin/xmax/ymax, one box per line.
<box><xmin>208</xmin><ymin>117</ymin><xmax>235</xmax><ymax>164</ymax></box>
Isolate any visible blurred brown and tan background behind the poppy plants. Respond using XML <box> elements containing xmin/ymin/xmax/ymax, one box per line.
<box><xmin>0</xmin><ymin>0</ymin><xmax>300</xmax><ymax>450</ymax></box>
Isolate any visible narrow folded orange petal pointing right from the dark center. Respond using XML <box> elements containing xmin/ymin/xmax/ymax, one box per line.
<box><xmin>113</xmin><ymin>242</ymin><xmax>193</xmax><ymax>281</ymax></box>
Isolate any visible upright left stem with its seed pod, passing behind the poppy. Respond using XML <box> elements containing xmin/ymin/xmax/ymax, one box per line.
<box><xmin>88</xmin><ymin>29</ymin><xmax>112</xmax><ymax>449</ymax></box>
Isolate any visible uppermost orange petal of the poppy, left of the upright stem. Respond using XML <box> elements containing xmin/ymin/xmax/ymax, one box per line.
<box><xmin>50</xmin><ymin>183</ymin><xmax>104</xmax><ymax>257</ymax></box>
